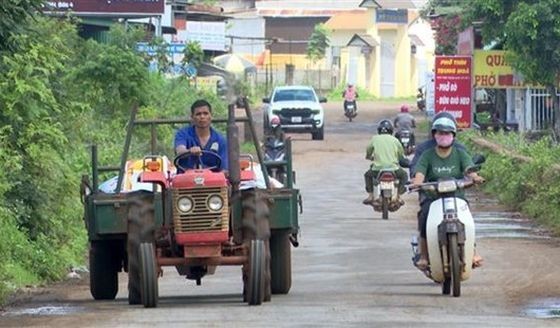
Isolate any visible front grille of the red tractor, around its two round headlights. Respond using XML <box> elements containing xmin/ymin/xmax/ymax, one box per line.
<box><xmin>173</xmin><ymin>187</ymin><xmax>229</xmax><ymax>233</ymax></box>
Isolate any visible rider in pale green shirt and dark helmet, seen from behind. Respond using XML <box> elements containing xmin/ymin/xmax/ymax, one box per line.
<box><xmin>362</xmin><ymin>120</ymin><xmax>408</xmax><ymax>205</ymax></box>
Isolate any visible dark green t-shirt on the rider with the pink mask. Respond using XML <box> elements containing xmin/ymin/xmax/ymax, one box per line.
<box><xmin>416</xmin><ymin>147</ymin><xmax>474</xmax><ymax>199</ymax></box>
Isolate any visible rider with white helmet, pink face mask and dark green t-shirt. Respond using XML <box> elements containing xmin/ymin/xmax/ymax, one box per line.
<box><xmin>412</xmin><ymin>117</ymin><xmax>484</xmax><ymax>270</ymax></box>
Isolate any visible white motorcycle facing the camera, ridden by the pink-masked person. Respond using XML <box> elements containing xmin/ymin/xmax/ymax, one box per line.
<box><xmin>411</xmin><ymin>157</ymin><xmax>484</xmax><ymax>297</ymax></box>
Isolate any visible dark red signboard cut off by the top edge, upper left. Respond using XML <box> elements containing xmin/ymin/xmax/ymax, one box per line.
<box><xmin>46</xmin><ymin>0</ymin><xmax>165</xmax><ymax>15</ymax></box>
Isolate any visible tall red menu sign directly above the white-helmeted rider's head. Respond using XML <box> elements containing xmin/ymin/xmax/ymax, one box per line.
<box><xmin>435</xmin><ymin>56</ymin><xmax>472</xmax><ymax>128</ymax></box>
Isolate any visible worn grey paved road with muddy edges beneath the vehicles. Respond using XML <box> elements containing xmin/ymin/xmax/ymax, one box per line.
<box><xmin>0</xmin><ymin>102</ymin><xmax>560</xmax><ymax>327</ymax></box>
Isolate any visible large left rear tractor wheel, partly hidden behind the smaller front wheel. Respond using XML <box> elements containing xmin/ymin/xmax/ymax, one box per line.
<box><xmin>127</xmin><ymin>192</ymin><xmax>155</xmax><ymax>304</ymax></box>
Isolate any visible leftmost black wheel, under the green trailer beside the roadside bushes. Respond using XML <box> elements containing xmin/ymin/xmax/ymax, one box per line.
<box><xmin>89</xmin><ymin>241</ymin><xmax>120</xmax><ymax>300</ymax></box>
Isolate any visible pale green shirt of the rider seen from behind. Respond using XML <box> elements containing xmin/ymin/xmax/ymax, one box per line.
<box><xmin>366</xmin><ymin>134</ymin><xmax>404</xmax><ymax>171</ymax></box>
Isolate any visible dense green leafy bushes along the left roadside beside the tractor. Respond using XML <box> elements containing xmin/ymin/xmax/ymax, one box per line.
<box><xmin>0</xmin><ymin>14</ymin><xmax>230</xmax><ymax>304</ymax></box>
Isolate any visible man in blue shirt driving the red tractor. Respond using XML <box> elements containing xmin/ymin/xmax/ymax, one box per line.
<box><xmin>175</xmin><ymin>99</ymin><xmax>228</xmax><ymax>173</ymax></box>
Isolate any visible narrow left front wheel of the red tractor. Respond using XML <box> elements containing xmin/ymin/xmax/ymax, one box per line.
<box><xmin>139</xmin><ymin>243</ymin><xmax>158</xmax><ymax>307</ymax></box>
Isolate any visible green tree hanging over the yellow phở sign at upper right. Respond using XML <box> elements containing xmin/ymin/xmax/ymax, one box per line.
<box><xmin>465</xmin><ymin>0</ymin><xmax>560</xmax><ymax>135</ymax></box>
